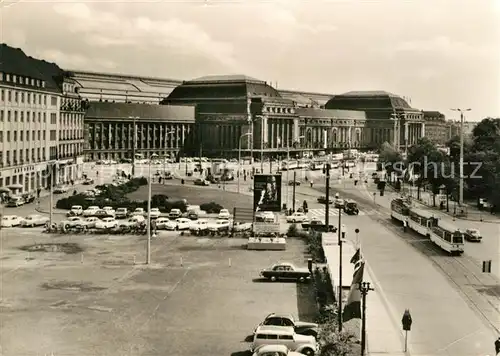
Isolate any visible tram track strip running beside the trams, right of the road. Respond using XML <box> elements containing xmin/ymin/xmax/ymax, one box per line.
<box><xmin>306</xmin><ymin>185</ymin><xmax>500</xmax><ymax>334</ymax></box>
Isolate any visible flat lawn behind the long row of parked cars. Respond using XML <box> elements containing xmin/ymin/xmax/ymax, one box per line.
<box><xmin>128</xmin><ymin>184</ymin><xmax>253</xmax><ymax>210</ymax></box>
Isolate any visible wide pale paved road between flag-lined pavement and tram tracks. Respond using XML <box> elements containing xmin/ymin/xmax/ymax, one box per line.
<box><xmin>294</xmin><ymin>185</ymin><xmax>496</xmax><ymax>356</ymax></box>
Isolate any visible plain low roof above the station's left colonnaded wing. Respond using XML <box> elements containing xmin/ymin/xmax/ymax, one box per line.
<box><xmin>85</xmin><ymin>102</ymin><xmax>195</xmax><ymax>122</ymax></box>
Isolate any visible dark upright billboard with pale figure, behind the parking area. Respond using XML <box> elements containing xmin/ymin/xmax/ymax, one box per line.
<box><xmin>253</xmin><ymin>174</ymin><xmax>281</xmax><ymax>211</ymax></box>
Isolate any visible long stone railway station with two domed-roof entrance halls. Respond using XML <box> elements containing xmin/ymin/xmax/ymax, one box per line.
<box><xmin>71</xmin><ymin>71</ymin><xmax>425</xmax><ymax>159</ymax></box>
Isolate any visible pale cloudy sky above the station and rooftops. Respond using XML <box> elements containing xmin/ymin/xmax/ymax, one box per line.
<box><xmin>0</xmin><ymin>0</ymin><xmax>500</xmax><ymax>121</ymax></box>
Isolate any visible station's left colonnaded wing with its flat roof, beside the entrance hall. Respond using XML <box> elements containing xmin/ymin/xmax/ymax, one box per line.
<box><xmin>85</xmin><ymin>102</ymin><xmax>196</xmax><ymax>160</ymax></box>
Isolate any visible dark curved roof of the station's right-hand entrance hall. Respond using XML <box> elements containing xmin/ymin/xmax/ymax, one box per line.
<box><xmin>325</xmin><ymin>90</ymin><xmax>414</xmax><ymax>111</ymax></box>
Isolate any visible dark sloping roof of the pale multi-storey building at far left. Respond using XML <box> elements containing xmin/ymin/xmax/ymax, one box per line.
<box><xmin>0</xmin><ymin>43</ymin><xmax>65</xmax><ymax>91</ymax></box>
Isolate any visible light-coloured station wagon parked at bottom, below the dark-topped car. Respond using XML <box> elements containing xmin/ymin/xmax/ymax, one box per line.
<box><xmin>250</xmin><ymin>325</ymin><xmax>319</xmax><ymax>356</ymax></box>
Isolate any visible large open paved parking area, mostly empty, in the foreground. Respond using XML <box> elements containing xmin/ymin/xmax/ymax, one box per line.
<box><xmin>0</xmin><ymin>228</ymin><xmax>315</xmax><ymax>356</ymax></box>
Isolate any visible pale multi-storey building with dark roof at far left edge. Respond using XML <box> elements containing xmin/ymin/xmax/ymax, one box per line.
<box><xmin>0</xmin><ymin>44</ymin><xmax>83</xmax><ymax>193</ymax></box>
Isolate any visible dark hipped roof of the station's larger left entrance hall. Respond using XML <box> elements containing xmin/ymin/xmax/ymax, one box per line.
<box><xmin>161</xmin><ymin>75</ymin><xmax>281</xmax><ymax>104</ymax></box>
